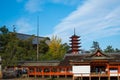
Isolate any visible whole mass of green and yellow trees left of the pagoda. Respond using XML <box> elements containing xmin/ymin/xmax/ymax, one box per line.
<box><xmin>0</xmin><ymin>26</ymin><xmax>69</xmax><ymax>66</ymax></box>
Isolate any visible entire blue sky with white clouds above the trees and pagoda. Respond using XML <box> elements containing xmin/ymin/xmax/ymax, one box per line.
<box><xmin>0</xmin><ymin>0</ymin><xmax>120</xmax><ymax>50</ymax></box>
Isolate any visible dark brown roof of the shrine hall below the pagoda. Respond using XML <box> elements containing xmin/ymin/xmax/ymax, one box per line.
<box><xmin>59</xmin><ymin>50</ymin><xmax>120</xmax><ymax>66</ymax></box>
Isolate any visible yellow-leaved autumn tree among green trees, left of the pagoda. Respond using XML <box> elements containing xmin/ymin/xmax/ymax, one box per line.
<box><xmin>42</xmin><ymin>36</ymin><xmax>68</xmax><ymax>60</ymax></box>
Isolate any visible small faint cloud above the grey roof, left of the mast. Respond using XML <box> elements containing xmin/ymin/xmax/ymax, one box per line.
<box><xmin>16</xmin><ymin>18</ymin><xmax>34</xmax><ymax>33</ymax></box>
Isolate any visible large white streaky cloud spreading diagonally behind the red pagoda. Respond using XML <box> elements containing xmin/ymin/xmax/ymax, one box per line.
<box><xmin>47</xmin><ymin>0</ymin><xmax>120</xmax><ymax>48</ymax></box>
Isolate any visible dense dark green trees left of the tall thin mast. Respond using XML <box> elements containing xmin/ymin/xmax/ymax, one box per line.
<box><xmin>0</xmin><ymin>26</ymin><xmax>36</xmax><ymax>66</ymax></box>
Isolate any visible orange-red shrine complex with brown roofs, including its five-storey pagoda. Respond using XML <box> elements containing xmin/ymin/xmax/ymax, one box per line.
<box><xmin>11</xmin><ymin>33</ymin><xmax>120</xmax><ymax>80</ymax></box>
